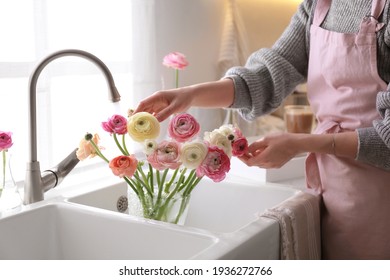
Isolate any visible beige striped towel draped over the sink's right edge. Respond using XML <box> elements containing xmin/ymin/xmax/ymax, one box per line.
<box><xmin>262</xmin><ymin>192</ymin><xmax>321</xmax><ymax>260</ymax></box>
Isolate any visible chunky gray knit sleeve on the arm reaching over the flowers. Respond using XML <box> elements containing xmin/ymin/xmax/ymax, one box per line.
<box><xmin>224</xmin><ymin>1</ymin><xmax>312</xmax><ymax>120</ymax></box>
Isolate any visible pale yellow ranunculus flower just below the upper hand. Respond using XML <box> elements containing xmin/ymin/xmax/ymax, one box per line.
<box><xmin>127</xmin><ymin>112</ymin><xmax>160</xmax><ymax>142</ymax></box>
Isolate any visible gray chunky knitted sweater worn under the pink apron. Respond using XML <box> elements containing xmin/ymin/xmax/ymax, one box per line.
<box><xmin>225</xmin><ymin>0</ymin><xmax>390</xmax><ymax>170</ymax></box>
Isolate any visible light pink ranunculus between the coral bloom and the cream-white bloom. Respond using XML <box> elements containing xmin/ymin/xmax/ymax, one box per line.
<box><xmin>147</xmin><ymin>141</ymin><xmax>181</xmax><ymax>170</ymax></box>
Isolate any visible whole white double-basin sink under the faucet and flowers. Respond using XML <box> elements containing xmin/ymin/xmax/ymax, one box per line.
<box><xmin>0</xmin><ymin>173</ymin><xmax>298</xmax><ymax>260</ymax></box>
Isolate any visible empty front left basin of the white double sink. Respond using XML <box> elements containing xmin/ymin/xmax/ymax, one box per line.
<box><xmin>0</xmin><ymin>202</ymin><xmax>218</xmax><ymax>259</ymax></box>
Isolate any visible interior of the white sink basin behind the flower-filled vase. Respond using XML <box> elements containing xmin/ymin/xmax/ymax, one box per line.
<box><xmin>68</xmin><ymin>178</ymin><xmax>297</xmax><ymax>233</ymax></box>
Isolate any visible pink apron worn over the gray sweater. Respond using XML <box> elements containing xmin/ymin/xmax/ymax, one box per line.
<box><xmin>306</xmin><ymin>0</ymin><xmax>390</xmax><ymax>259</ymax></box>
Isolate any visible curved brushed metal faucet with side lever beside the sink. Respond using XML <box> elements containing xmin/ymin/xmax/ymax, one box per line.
<box><xmin>24</xmin><ymin>49</ymin><xmax>120</xmax><ymax>204</ymax></box>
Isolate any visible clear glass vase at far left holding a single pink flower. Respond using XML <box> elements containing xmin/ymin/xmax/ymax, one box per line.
<box><xmin>0</xmin><ymin>150</ymin><xmax>22</xmax><ymax>212</ymax></box>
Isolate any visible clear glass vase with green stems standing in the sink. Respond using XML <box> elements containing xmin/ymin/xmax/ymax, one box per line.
<box><xmin>128</xmin><ymin>188</ymin><xmax>191</xmax><ymax>225</ymax></box>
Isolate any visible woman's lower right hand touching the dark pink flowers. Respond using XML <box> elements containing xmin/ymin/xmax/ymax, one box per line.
<box><xmin>240</xmin><ymin>133</ymin><xmax>303</xmax><ymax>169</ymax></box>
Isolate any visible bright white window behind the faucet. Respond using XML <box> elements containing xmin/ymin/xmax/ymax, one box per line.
<box><xmin>0</xmin><ymin>0</ymin><xmax>132</xmax><ymax>181</ymax></box>
